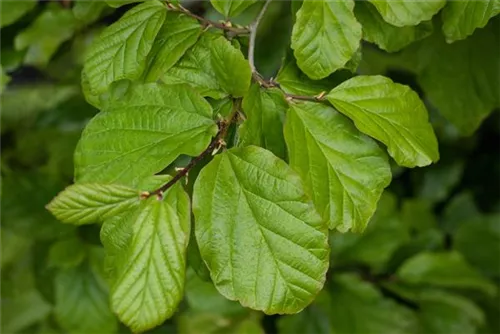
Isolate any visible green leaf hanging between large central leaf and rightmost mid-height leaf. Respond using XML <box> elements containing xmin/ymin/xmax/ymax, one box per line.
<box><xmin>285</xmin><ymin>102</ymin><xmax>391</xmax><ymax>232</ymax></box>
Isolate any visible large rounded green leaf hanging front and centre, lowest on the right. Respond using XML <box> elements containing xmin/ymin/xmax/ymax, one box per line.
<box><xmin>193</xmin><ymin>146</ymin><xmax>328</xmax><ymax>314</ymax></box>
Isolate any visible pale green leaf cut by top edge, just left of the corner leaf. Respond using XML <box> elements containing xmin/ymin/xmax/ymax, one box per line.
<box><xmin>368</xmin><ymin>0</ymin><xmax>446</xmax><ymax>27</ymax></box>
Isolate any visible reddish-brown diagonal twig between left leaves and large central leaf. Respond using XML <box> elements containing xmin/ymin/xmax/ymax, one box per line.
<box><xmin>146</xmin><ymin>100</ymin><xmax>241</xmax><ymax>199</ymax></box>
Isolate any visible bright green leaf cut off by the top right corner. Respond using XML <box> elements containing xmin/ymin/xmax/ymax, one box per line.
<box><xmin>442</xmin><ymin>0</ymin><xmax>500</xmax><ymax>43</ymax></box>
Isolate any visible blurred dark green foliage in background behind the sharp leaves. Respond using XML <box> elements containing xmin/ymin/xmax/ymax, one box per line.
<box><xmin>0</xmin><ymin>0</ymin><xmax>500</xmax><ymax>334</ymax></box>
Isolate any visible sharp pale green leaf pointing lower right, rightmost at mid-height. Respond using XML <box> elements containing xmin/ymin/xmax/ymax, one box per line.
<box><xmin>327</xmin><ymin>76</ymin><xmax>439</xmax><ymax>167</ymax></box>
